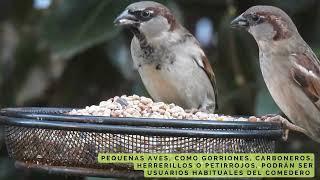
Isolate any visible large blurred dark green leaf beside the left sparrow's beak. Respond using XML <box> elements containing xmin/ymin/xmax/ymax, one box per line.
<box><xmin>40</xmin><ymin>0</ymin><xmax>123</xmax><ymax>58</ymax></box>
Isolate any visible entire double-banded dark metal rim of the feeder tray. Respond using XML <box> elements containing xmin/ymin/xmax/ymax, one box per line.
<box><xmin>0</xmin><ymin>108</ymin><xmax>282</xmax><ymax>139</ymax></box>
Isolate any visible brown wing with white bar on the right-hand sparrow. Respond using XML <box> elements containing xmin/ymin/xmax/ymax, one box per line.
<box><xmin>290</xmin><ymin>51</ymin><xmax>320</xmax><ymax>111</ymax></box>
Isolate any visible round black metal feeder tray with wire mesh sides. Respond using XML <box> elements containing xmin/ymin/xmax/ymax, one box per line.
<box><xmin>0</xmin><ymin>108</ymin><xmax>282</xmax><ymax>178</ymax></box>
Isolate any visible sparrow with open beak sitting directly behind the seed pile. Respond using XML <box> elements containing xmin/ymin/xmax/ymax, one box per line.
<box><xmin>114</xmin><ymin>1</ymin><xmax>217</xmax><ymax>112</ymax></box>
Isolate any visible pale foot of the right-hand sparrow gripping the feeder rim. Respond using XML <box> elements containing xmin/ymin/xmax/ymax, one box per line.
<box><xmin>261</xmin><ymin>115</ymin><xmax>307</xmax><ymax>141</ymax></box>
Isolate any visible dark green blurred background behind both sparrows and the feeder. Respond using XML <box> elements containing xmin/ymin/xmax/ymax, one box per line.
<box><xmin>0</xmin><ymin>0</ymin><xmax>320</xmax><ymax>180</ymax></box>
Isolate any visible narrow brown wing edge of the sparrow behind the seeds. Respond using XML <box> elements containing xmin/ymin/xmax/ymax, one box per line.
<box><xmin>193</xmin><ymin>51</ymin><xmax>219</xmax><ymax>109</ymax></box>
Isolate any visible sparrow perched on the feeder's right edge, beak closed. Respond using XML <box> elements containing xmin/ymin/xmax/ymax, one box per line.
<box><xmin>231</xmin><ymin>6</ymin><xmax>320</xmax><ymax>142</ymax></box>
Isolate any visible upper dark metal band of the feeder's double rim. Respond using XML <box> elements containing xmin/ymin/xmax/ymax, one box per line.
<box><xmin>0</xmin><ymin>108</ymin><xmax>281</xmax><ymax>130</ymax></box>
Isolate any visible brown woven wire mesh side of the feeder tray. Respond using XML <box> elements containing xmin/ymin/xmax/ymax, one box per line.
<box><xmin>5</xmin><ymin>126</ymin><xmax>274</xmax><ymax>168</ymax></box>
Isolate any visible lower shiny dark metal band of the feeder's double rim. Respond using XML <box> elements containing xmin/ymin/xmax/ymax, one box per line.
<box><xmin>0</xmin><ymin>116</ymin><xmax>282</xmax><ymax>139</ymax></box>
